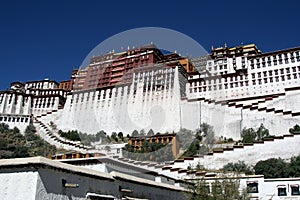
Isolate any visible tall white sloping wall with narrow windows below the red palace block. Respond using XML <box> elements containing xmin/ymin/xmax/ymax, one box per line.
<box><xmin>55</xmin><ymin>67</ymin><xmax>181</xmax><ymax>134</ymax></box>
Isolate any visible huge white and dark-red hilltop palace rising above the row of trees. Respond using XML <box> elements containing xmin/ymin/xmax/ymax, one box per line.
<box><xmin>0</xmin><ymin>44</ymin><xmax>300</xmax><ymax>139</ymax></box>
